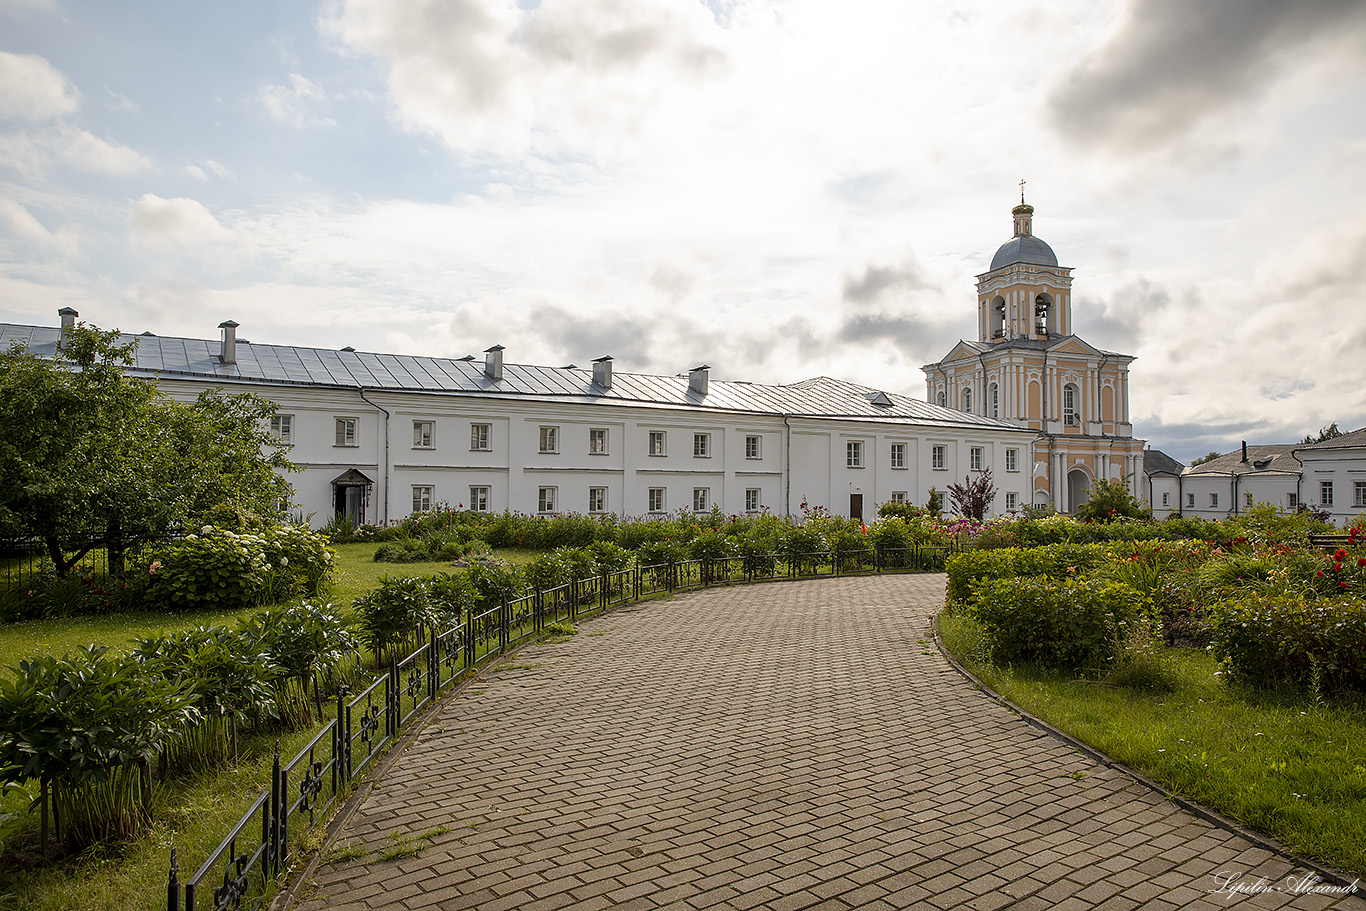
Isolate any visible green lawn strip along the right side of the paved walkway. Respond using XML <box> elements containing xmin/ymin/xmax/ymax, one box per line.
<box><xmin>938</xmin><ymin>613</ymin><xmax>1366</xmax><ymax>878</ymax></box>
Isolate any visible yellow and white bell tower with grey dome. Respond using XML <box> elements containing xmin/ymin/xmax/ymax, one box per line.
<box><xmin>923</xmin><ymin>199</ymin><xmax>1143</xmax><ymax>512</ymax></box>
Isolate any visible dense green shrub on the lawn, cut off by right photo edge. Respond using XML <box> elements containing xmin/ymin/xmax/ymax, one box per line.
<box><xmin>1210</xmin><ymin>595</ymin><xmax>1366</xmax><ymax>695</ymax></box>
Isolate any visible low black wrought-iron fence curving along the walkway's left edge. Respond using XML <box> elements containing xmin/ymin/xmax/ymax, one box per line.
<box><xmin>167</xmin><ymin>545</ymin><xmax>959</xmax><ymax>911</ymax></box>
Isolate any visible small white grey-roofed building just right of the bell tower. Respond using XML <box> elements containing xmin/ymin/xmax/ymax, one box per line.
<box><xmin>1180</xmin><ymin>443</ymin><xmax>1300</xmax><ymax>519</ymax></box>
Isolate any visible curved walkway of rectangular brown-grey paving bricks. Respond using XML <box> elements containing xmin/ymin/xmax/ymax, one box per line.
<box><xmin>299</xmin><ymin>575</ymin><xmax>1366</xmax><ymax>911</ymax></box>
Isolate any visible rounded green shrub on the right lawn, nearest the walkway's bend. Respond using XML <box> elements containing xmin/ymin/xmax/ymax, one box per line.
<box><xmin>971</xmin><ymin>576</ymin><xmax>1142</xmax><ymax>671</ymax></box>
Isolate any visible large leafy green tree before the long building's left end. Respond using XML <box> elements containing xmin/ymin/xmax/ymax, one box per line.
<box><xmin>0</xmin><ymin>324</ymin><xmax>294</xmax><ymax>576</ymax></box>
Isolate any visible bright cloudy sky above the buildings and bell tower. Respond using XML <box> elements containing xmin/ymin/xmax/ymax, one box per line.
<box><xmin>0</xmin><ymin>0</ymin><xmax>1366</xmax><ymax>460</ymax></box>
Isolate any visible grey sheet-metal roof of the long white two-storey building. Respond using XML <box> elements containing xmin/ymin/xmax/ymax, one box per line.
<box><xmin>0</xmin><ymin>324</ymin><xmax>1022</xmax><ymax>432</ymax></box>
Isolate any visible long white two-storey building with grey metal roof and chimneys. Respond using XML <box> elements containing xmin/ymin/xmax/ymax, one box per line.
<box><xmin>0</xmin><ymin>309</ymin><xmax>1037</xmax><ymax>526</ymax></box>
